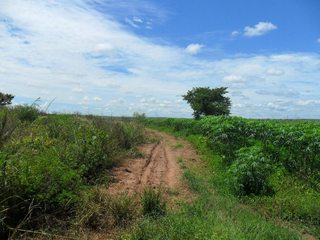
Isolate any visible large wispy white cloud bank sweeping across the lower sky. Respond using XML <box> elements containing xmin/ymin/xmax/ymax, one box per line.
<box><xmin>0</xmin><ymin>0</ymin><xmax>320</xmax><ymax>118</ymax></box>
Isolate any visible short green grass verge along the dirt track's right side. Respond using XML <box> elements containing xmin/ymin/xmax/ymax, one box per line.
<box><xmin>122</xmin><ymin>128</ymin><xmax>302</xmax><ymax>240</ymax></box>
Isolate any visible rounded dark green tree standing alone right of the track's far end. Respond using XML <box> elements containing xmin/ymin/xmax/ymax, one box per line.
<box><xmin>182</xmin><ymin>87</ymin><xmax>231</xmax><ymax>119</ymax></box>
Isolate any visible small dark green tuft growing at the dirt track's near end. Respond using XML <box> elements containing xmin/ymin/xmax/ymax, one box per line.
<box><xmin>141</xmin><ymin>188</ymin><xmax>166</xmax><ymax>218</ymax></box>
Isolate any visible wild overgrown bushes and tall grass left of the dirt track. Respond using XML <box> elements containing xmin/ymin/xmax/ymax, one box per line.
<box><xmin>0</xmin><ymin>106</ymin><xmax>144</xmax><ymax>239</ymax></box>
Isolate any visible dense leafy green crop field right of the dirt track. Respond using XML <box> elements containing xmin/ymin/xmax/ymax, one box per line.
<box><xmin>146</xmin><ymin>117</ymin><xmax>320</xmax><ymax>237</ymax></box>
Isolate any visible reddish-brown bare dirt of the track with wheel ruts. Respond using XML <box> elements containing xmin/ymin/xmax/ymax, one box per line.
<box><xmin>108</xmin><ymin>130</ymin><xmax>196</xmax><ymax>194</ymax></box>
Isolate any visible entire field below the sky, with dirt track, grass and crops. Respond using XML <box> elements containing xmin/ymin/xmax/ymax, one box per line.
<box><xmin>0</xmin><ymin>106</ymin><xmax>320</xmax><ymax>239</ymax></box>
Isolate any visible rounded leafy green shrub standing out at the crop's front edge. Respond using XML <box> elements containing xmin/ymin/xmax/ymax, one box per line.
<box><xmin>229</xmin><ymin>145</ymin><xmax>273</xmax><ymax>196</ymax></box>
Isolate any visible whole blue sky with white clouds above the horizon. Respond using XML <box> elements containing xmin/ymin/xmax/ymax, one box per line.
<box><xmin>0</xmin><ymin>0</ymin><xmax>320</xmax><ymax>119</ymax></box>
